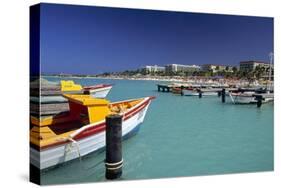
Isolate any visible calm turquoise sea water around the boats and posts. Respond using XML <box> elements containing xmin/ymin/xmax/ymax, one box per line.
<box><xmin>41</xmin><ymin>78</ymin><xmax>273</xmax><ymax>184</ymax></box>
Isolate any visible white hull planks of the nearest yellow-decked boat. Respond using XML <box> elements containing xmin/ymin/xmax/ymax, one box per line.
<box><xmin>30</xmin><ymin>97</ymin><xmax>151</xmax><ymax>170</ymax></box>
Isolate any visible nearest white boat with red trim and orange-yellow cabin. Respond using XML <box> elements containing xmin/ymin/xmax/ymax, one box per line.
<box><xmin>30</xmin><ymin>94</ymin><xmax>155</xmax><ymax>169</ymax></box>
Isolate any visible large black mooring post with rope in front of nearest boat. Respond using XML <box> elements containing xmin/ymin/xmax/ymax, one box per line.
<box><xmin>105</xmin><ymin>114</ymin><xmax>123</xmax><ymax>179</ymax></box>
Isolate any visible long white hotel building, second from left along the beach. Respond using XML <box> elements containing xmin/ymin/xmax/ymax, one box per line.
<box><xmin>165</xmin><ymin>64</ymin><xmax>200</xmax><ymax>74</ymax></box>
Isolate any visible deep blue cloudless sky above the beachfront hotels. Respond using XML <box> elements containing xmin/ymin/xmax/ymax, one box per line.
<box><xmin>40</xmin><ymin>4</ymin><xmax>273</xmax><ymax>74</ymax></box>
